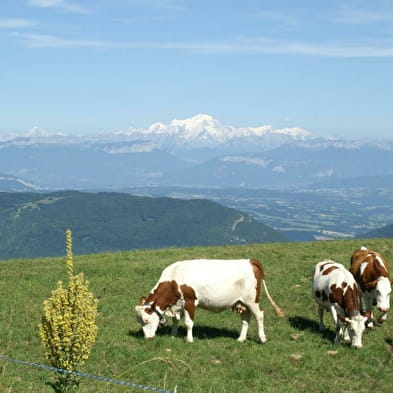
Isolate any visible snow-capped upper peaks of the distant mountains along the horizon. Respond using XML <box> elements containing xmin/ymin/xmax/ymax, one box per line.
<box><xmin>5</xmin><ymin>114</ymin><xmax>393</xmax><ymax>154</ymax></box>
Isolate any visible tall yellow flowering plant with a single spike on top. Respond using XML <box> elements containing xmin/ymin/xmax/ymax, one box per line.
<box><xmin>39</xmin><ymin>230</ymin><xmax>98</xmax><ymax>392</ymax></box>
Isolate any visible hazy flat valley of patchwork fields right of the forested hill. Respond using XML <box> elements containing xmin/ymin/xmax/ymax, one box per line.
<box><xmin>133</xmin><ymin>185</ymin><xmax>393</xmax><ymax>242</ymax></box>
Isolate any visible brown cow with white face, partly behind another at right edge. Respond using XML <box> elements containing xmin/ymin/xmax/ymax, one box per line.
<box><xmin>349</xmin><ymin>247</ymin><xmax>392</xmax><ymax>327</ymax></box>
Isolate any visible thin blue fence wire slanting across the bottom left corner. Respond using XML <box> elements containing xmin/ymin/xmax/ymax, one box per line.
<box><xmin>0</xmin><ymin>355</ymin><xmax>177</xmax><ymax>393</ymax></box>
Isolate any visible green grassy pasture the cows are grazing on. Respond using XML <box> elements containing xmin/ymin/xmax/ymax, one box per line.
<box><xmin>0</xmin><ymin>239</ymin><xmax>393</xmax><ymax>393</ymax></box>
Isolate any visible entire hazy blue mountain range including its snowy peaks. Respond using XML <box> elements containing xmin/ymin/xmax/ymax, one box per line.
<box><xmin>0</xmin><ymin>115</ymin><xmax>393</xmax><ymax>190</ymax></box>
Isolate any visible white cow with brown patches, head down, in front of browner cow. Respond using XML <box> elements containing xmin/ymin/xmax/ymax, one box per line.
<box><xmin>312</xmin><ymin>259</ymin><xmax>367</xmax><ymax>348</ymax></box>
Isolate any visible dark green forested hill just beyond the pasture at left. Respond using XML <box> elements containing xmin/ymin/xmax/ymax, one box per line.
<box><xmin>0</xmin><ymin>191</ymin><xmax>286</xmax><ymax>259</ymax></box>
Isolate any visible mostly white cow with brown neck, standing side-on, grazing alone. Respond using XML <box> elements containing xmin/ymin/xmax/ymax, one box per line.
<box><xmin>135</xmin><ymin>259</ymin><xmax>284</xmax><ymax>343</ymax></box>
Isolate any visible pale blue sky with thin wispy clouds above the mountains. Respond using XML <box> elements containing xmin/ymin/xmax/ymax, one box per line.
<box><xmin>0</xmin><ymin>0</ymin><xmax>393</xmax><ymax>139</ymax></box>
